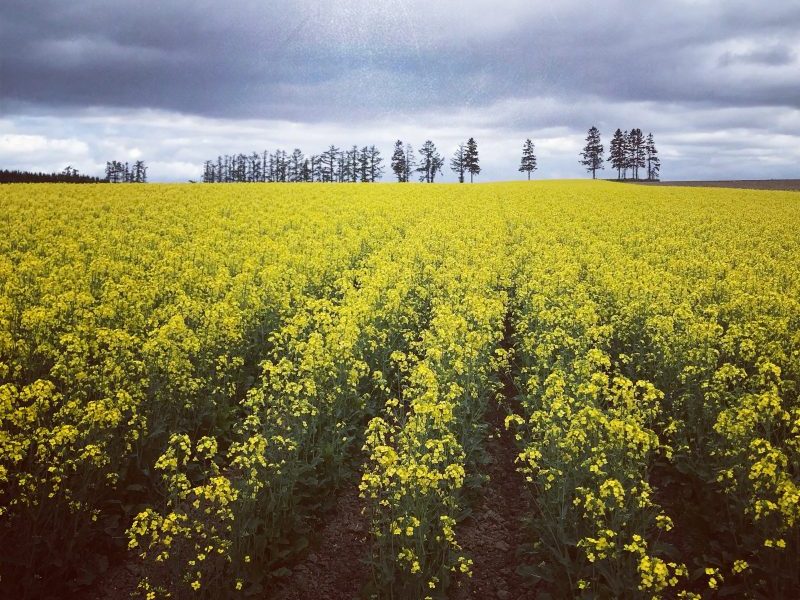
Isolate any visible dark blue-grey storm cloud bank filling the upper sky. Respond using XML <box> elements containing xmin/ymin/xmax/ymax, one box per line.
<box><xmin>0</xmin><ymin>0</ymin><xmax>800</xmax><ymax>120</ymax></box>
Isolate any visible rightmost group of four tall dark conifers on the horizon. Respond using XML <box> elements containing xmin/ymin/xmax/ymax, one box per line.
<box><xmin>581</xmin><ymin>126</ymin><xmax>661</xmax><ymax>181</ymax></box>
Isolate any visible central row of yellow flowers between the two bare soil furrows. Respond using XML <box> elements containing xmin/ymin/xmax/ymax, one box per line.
<box><xmin>361</xmin><ymin>205</ymin><xmax>507</xmax><ymax>598</ymax></box>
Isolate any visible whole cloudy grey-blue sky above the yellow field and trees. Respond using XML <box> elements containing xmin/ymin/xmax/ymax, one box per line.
<box><xmin>0</xmin><ymin>0</ymin><xmax>800</xmax><ymax>181</ymax></box>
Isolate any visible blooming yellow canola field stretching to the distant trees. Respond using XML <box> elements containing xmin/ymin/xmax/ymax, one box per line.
<box><xmin>0</xmin><ymin>181</ymin><xmax>800</xmax><ymax>599</ymax></box>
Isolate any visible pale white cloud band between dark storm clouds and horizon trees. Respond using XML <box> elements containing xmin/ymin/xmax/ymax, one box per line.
<box><xmin>0</xmin><ymin>97</ymin><xmax>800</xmax><ymax>181</ymax></box>
